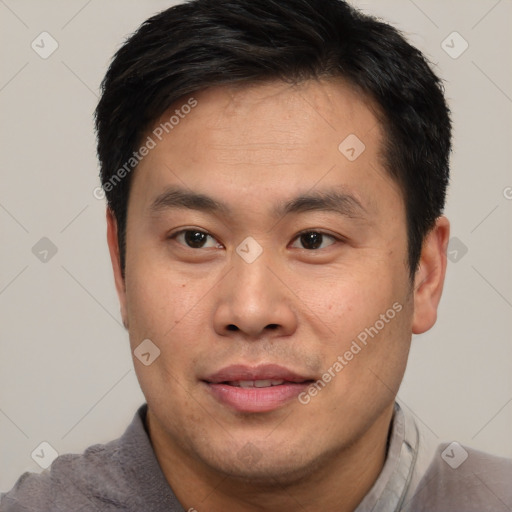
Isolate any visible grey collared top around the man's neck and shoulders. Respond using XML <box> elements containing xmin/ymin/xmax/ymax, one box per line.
<box><xmin>0</xmin><ymin>403</ymin><xmax>512</xmax><ymax>512</ymax></box>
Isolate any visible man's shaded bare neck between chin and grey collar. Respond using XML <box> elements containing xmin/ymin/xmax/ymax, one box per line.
<box><xmin>146</xmin><ymin>404</ymin><xmax>394</xmax><ymax>512</ymax></box>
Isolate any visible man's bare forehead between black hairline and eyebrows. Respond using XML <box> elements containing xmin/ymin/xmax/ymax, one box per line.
<box><xmin>128</xmin><ymin>80</ymin><xmax>397</xmax><ymax>216</ymax></box>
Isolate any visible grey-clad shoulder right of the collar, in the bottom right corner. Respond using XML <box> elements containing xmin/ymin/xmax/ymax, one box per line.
<box><xmin>410</xmin><ymin>442</ymin><xmax>512</xmax><ymax>512</ymax></box>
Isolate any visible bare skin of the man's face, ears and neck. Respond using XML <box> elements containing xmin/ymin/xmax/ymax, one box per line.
<box><xmin>107</xmin><ymin>80</ymin><xmax>449</xmax><ymax>512</ymax></box>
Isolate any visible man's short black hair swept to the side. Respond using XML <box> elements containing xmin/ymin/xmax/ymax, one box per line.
<box><xmin>95</xmin><ymin>0</ymin><xmax>451</xmax><ymax>277</ymax></box>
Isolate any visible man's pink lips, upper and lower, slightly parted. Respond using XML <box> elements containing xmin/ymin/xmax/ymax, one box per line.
<box><xmin>202</xmin><ymin>364</ymin><xmax>314</xmax><ymax>413</ymax></box>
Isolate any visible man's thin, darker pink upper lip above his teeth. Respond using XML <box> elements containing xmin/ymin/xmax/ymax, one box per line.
<box><xmin>203</xmin><ymin>364</ymin><xmax>312</xmax><ymax>384</ymax></box>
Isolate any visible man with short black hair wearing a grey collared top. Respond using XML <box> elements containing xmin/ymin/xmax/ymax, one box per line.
<box><xmin>1</xmin><ymin>0</ymin><xmax>512</xmax><ymax>512</ymax></box>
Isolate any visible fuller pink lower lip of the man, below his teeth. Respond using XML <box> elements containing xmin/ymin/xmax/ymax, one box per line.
<box><xmin>206</xmin><ymin>382</ymin><xmax>309</xmax><ymax>412</ymax></box>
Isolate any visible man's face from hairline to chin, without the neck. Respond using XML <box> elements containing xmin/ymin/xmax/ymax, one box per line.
<box><xmin>110</xmin><ymin>81</ymin><xmax>440</xmax><ymax>481</ymax></box>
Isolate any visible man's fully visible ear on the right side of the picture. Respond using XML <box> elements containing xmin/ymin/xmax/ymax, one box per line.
<box><xmin>412</xmin><ymin>215</ymin><xmax>450</xmax><ymax>334</ymax></box>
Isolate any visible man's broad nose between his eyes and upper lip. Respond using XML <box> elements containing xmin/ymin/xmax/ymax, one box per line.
<box><xmin>214</xmin><ymin>251</ymin><xmax>297</xmax><ymax>340</ymax></box>
